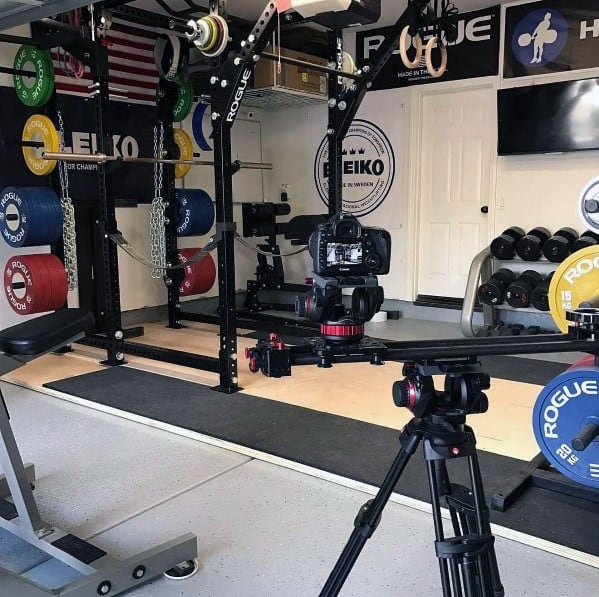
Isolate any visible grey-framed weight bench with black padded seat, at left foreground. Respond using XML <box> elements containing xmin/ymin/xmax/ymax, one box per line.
<box><xmin>0</xmin><ymin>309</ymin><xmax>197</xmax><ymax>597</ymax></box>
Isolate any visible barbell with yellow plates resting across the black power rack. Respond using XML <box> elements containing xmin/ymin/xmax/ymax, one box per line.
<box><xmin>21</xmin><ymin>114</ymin><xmax>273</xmax><ymax>178</ymax></box>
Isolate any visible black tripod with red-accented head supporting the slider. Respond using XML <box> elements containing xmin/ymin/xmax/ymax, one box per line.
<box><xmin>320</xmin><ymin>364</ymin><xmax>505</xmax><ymax>597</ymax></box>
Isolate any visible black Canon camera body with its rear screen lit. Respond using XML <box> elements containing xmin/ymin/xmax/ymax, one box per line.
<box><xmin>309</xmin><ymin>214</ymin><xmax>391</xmax><ymax>277</ymax></box>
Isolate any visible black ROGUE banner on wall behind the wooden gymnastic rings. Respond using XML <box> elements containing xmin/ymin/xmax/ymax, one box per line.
<box><xmin>356</xmin><ymin>6</ymin><xmax>500</xmax><ymax>90</ymax></box>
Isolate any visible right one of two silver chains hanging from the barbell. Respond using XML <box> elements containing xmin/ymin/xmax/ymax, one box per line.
<box><xmin>150</xmin><ymin>122</ymin><xmax>166</xmax><ymax>279</ymax></box>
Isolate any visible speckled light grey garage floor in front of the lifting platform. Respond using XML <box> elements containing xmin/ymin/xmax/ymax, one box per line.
<box><xmin>0</xmin><ymin>385</ymin><xmax>599</xmax><ymax>597</ymax></box>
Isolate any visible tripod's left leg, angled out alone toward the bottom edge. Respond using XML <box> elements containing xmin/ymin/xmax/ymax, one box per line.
<box><xmin>320</xmin><ymin>428</ymin><xmax>420</xmax><ymax>597</ymax></box>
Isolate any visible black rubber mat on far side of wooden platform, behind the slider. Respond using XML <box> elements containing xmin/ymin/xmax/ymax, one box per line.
<box><xmin>244</xmin><ymin>332</ymin><xmax>570</xmax><ymax>386</ymax></box>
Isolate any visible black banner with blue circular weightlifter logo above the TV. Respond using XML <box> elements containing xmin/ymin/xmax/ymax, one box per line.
<box><xmin>503</xmin><ymin>0</ymin><xmax>599</xmax><ymax>78</ymax></box>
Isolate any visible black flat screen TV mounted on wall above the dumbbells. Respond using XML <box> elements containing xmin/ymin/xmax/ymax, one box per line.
<box><xmin>497</xmin><ymin>79</ymin><xmax>599</xmax><ymax>155</ymax></box>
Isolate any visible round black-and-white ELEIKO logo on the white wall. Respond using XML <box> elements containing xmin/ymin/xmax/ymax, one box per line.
<box><xmin>314</xmin><ymin>120</ymin><xmax>395</xmax><ymax>216</ymax></box>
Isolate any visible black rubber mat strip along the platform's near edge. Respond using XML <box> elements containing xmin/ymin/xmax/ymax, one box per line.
<box><xmin>46</xmin><ymin>367</ymin><xmax>599</xmax><ymax>556</ymax></box>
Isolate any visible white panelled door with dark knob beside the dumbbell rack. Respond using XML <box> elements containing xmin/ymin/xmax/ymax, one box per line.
<box><xmin>417</xmin><ymin>86</ymin><xmax>496</xmax><ymax>298</ymax></box>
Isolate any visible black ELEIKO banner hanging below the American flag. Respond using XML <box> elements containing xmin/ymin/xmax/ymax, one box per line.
<box><xmin>0</xmin><ymin>87</ymin><xmax>156</xmax><ymax>203</ymax></box>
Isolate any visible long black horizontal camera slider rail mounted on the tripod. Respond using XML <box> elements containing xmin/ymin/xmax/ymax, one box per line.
<box><xmin>246</xmin><ymin>322</ymin><xmax>599</xmax><ymax>377</ymax></box>
